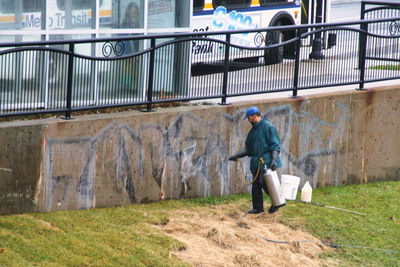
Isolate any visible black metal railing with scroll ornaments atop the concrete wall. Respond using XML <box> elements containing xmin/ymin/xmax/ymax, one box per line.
<box><xmin>0</xmin><ymin>17</ymin><xmax>400</xmax><ymax>118</ymax></box>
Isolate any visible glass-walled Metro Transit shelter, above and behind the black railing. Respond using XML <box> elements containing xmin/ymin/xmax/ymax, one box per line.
<box><xmin>0</xmin><ymin>0</ymin><xmax>191</xmax><ymax>111</ymax></box>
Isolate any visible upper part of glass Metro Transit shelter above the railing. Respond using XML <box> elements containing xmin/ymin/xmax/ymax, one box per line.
<box><xmin>0</xmin><ymin>0</ymin><xmax>192</xmax><ymax>42</ymax></box>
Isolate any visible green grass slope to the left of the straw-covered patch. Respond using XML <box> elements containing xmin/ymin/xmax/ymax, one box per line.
<box><xmin>0</xmin><ymin>205</ymin><xmax>187</xmax><ymax>266</ymax></box>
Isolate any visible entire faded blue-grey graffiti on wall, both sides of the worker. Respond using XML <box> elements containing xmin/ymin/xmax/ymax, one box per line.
<box><xmin>43</xmin><ymin>101</ymin><xmax>347</xmax><ymax>211</ymax></box>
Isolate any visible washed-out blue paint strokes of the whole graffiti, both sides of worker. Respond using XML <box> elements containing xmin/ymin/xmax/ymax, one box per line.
<box><xmin>44</xmin><ymin>102</ymin><xmax>348</xmax><ymax>211</ymax></box>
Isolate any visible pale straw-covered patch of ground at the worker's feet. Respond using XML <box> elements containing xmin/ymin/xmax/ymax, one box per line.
<box><xmin>155</xmin><ymin>205</ymin><xmax>335</xmax><ymax>267</ymax></box>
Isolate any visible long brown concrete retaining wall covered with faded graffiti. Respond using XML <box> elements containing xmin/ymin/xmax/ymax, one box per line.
<box><xmin>0</xmin><ymin>87</ymin><xmax>400</xmax><ymax>214</ymax></box>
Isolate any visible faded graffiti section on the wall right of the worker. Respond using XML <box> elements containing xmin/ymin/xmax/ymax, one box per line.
<box><xmin>263</xmin><ymin>101</ymin><xmax>348</xmax><ymax>186</ymax></box>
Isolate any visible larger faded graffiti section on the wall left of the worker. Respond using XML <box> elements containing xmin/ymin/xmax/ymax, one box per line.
<box><xmin>44</xmin><ymin>113</ymin><xmax>231</xmax><ymax>210</ymax></box>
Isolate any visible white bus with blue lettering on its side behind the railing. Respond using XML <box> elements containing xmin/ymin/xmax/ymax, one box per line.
<box><xmin>191</xmin><ymin>0</ymin><xmax>301</xmax><ymax>65</ymax></box>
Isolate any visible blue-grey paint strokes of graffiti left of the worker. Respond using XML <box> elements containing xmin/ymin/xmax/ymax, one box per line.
<box><xmin>44</xmin><ymin>114</ymin><xmax>230</xmax><ymax>211</ymax></box>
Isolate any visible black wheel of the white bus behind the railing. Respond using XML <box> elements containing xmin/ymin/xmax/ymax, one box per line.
<box><xmin>264</xmin><ymin>31</ymin><xmax>284</xmax><ymax>65</ymax></box>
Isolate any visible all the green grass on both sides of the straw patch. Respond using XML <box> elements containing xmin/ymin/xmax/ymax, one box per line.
<box><xmin>0</xmin><ymin>182</ymin><xmax>400</xmax><ymax>266</ymax></box>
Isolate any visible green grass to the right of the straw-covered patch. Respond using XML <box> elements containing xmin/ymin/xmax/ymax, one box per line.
<box><xmin>279</xmin><ymin>182</ymin><xmax>400</xmax><ymax>266</ymax></box>
